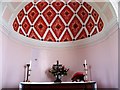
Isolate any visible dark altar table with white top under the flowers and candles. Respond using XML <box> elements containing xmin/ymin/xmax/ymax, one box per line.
<box><xmin>19</xmin><ymin>81</ymin><xmax>97</xmax><ymax>90</ymax></box>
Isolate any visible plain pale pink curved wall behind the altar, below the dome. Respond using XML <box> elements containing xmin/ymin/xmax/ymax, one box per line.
<box><xmin>2</xmin><ymin>31</ymin><xmax>118</xmax><ymax>88</ymax></box>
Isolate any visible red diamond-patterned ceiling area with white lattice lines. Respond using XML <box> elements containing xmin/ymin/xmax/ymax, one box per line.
<box><xmin>13</xmin><ymin>1</ymin><xmax>104</xmax><ymax>42</ymax></box>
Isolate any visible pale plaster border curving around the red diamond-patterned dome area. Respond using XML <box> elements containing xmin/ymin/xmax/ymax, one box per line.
<box><xmin>0</xmin><ymin>2</ymin><xmax>117</xmax><ymax>47</ymax></box>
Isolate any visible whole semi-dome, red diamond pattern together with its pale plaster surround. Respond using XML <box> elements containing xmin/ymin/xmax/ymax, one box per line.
<box><xmin>0</xmin><ymin>0</ymin><xmax>118</xmax><ymax>47</ymax></box>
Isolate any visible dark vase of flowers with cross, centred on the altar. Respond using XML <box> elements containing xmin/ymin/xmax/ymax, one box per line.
<box><xmin>49</xmin><ymin>60</ymin><xmax>69</xmax><ymax>82</ymax></box>
